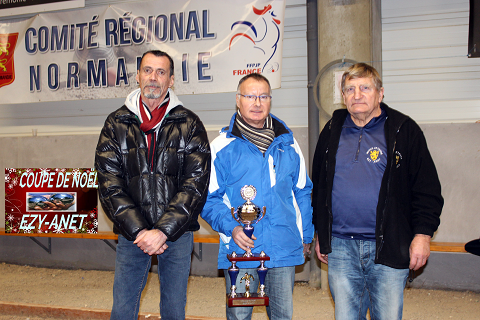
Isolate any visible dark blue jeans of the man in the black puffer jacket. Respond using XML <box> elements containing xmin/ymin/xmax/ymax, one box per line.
<box><xmin>110</xmin><ymin>232</ymin><xmax>193</xmax><ymax>320</ymax></box>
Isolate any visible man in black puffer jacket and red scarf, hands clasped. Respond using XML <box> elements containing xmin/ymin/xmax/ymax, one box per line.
<box><xmin>95</xmin><ymin>50</ymin><xmax>210</xmax><ymax>320</ymax></box>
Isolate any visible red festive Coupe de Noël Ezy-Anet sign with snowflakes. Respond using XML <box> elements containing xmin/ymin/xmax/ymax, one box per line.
<box><xmin>5</xmin><ymin>168</ymin><xmax>98</xmax><ymax>233</ymax></box>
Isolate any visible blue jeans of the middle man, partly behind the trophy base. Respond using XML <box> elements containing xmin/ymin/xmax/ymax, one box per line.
<box><xmin>224</xmin><ymin>267</ymin><xmax>295</xmax><ymax>320</ymax></box>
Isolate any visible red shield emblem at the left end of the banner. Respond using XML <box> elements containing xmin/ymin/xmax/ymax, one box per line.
<box><xmin>0</xmin><ymin>33</ymin><xmax>18</xmax><ymax>88</ymax></box>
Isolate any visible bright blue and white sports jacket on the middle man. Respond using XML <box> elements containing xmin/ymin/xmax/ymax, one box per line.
<box><xmin>201</xmin><ymin>114</ymin><xmax>314</xmax><ymax>269</ymax></box>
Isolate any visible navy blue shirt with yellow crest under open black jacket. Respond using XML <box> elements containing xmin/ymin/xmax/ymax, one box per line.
<box><xmin>332</xmin><ymin>110</ymin><xmax>387</xmax><ymax>240</ymax></box>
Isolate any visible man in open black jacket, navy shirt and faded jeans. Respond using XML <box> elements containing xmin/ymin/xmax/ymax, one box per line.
<box><xmin>312</xmin><ymin>63</ymin><xmax>443</xmax><ymax>320</ymax></box>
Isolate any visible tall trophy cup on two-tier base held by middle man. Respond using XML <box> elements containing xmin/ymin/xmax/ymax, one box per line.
<box><xmin>227</xmin><ymin>185</ymin><xmax>270</xmax><ymax>307</ymax></box>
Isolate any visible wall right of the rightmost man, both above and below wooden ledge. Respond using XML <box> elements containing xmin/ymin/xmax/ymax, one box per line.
<box><xmin>409</xmin><ymin>123</ymin><xmax>480</xmax><ymax>292</ymax></box>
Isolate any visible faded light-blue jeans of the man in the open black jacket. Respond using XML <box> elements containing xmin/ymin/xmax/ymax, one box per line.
<box><xmin>328</xmin><ymin>237</ymin><xmax>409</xmax><ymax>320</ymax></box>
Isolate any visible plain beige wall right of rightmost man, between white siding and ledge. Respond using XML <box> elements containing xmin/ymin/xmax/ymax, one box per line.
<box><xmin>421</xmin><ymin>123</ymin><xmax>480</xmax><ymax>242</ymax></box>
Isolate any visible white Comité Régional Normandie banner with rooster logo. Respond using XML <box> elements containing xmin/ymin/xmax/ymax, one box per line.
<box><xmin>0</xmin><ymin>0</ymin><xmax>285</xmax><ymax>103</ymax></box>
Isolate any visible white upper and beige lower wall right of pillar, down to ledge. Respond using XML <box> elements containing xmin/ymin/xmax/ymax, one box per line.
<box><xmin>382</xmin><ymin>0</ymin><xmax>480</xmax><ymax>242</ymax></box>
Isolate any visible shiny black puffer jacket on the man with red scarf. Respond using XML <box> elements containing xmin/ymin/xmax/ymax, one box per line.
<box><xmin>95</xmin><ymin>105</ymin><xmax>210</xmax><ymax>241</ymax></box>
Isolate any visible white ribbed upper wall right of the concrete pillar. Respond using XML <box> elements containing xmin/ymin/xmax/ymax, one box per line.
<box><xmin>382</xmin><ymin>0</ymin><xmax>480</xmax><ymax>123</ymax></box>
